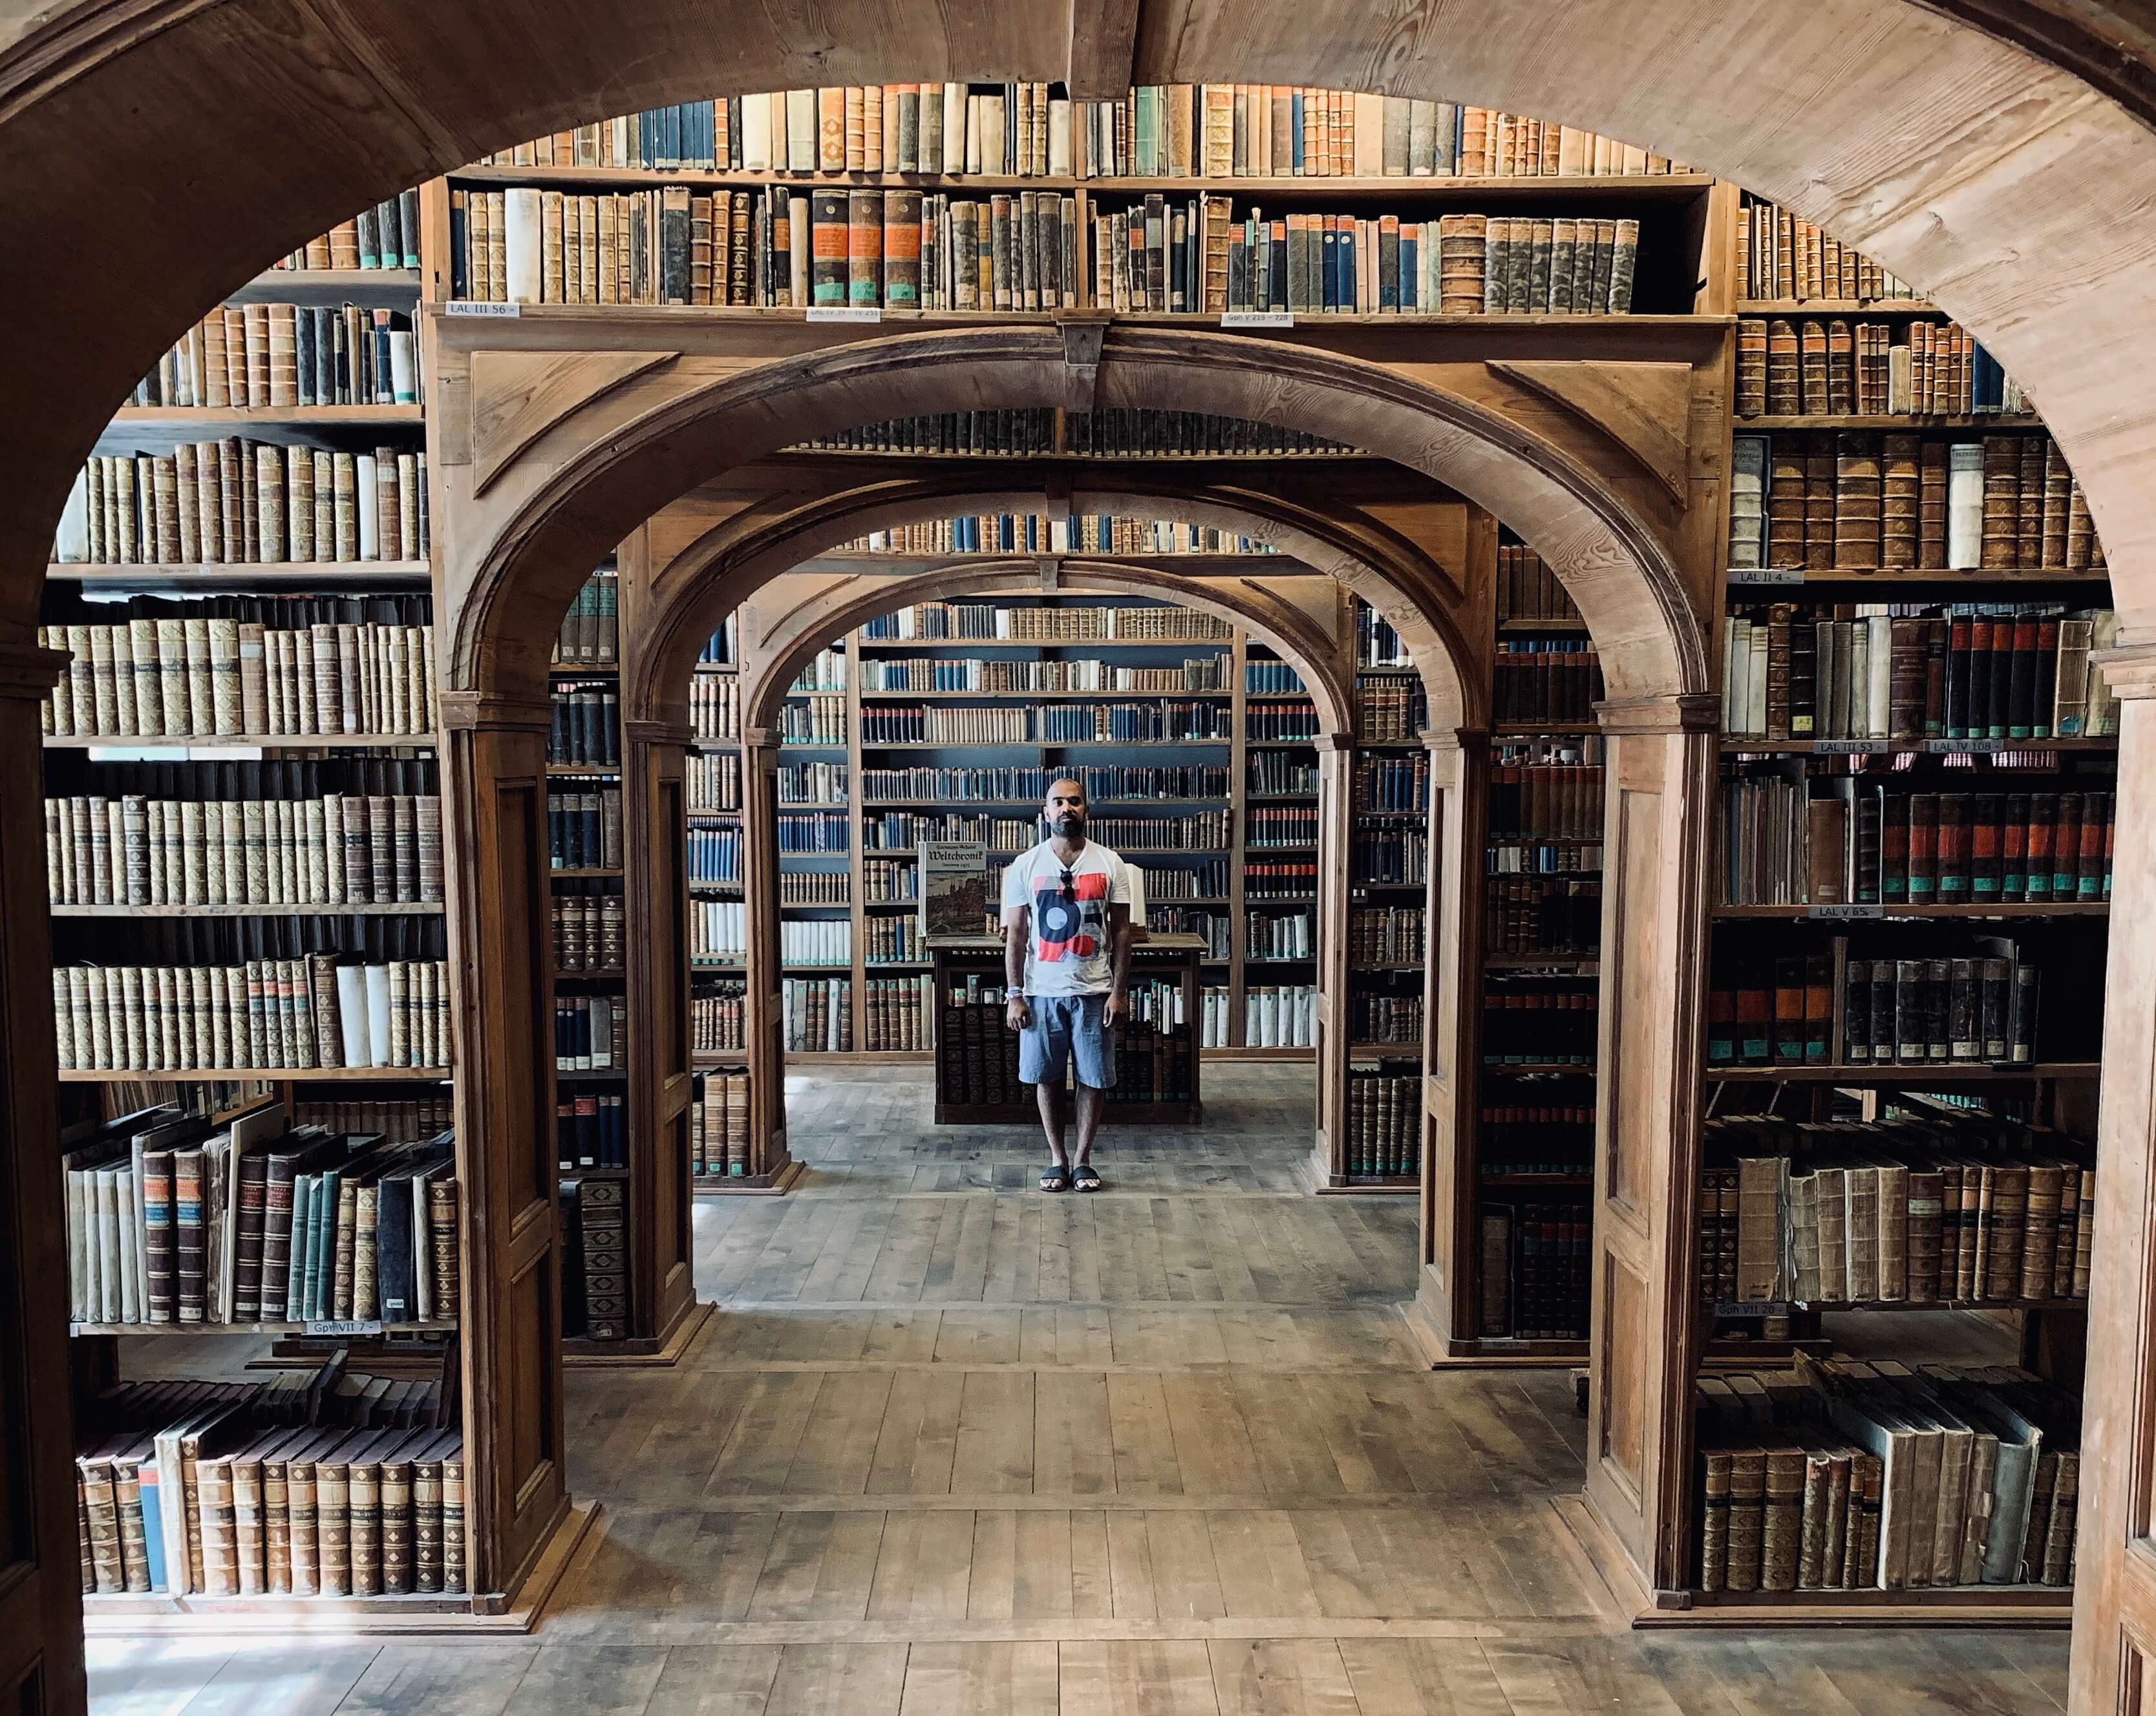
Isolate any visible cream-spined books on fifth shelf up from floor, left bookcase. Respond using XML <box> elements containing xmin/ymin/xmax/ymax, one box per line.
<box><xmin>39</xmin><ymin>597</ymin><xmax>433</xmax><ymax>740</ymax></box>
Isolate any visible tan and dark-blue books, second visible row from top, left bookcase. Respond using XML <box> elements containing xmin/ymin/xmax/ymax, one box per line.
<box><xmin>129</xmin><ymin>304</ymin><xmax>420</xmax><ymax>412</ymax></box>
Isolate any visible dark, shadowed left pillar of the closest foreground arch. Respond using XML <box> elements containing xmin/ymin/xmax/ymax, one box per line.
<box><xmin>0</xmin><ymin>643</ymin><xmax>89</xmax><ymax>1716</ymax></box>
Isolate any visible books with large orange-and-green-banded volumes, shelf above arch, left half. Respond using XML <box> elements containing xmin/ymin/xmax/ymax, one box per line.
<box><xmin>451</xmin><ymin>186</ymin><xmax>1082</xmax><ymax>310</ymax></box>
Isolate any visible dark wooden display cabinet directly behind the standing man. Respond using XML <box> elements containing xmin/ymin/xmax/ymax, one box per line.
<box><xmin>927</xmin><ymin>929</ymin><xmax>1205</xmax><ymax>1125</ymax></box>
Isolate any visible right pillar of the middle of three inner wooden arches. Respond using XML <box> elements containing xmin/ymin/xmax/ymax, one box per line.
<box><xmin>1408</xmin><ymin>729</ymin><xmax>1489</xmax><ymax>1362</ymax></box>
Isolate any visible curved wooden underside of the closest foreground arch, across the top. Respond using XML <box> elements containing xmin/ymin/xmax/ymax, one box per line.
<box><xmin>0</xmin><ymin>0</ymin><xmax>2156</xmax><ymax>632</ymax></box>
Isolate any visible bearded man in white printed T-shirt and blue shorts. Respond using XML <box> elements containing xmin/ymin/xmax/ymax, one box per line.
<box><xmin>1003</xmin><ymin>776</ymin><xmax>1132</xmax><ymax>1192</ymax></box>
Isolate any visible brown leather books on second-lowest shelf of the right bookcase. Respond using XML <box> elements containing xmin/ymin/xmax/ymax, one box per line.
<box><xmin>1699</xmin><ymin>1097</ymin><xmax>2096</xmax><ymax>1304</ymax></box>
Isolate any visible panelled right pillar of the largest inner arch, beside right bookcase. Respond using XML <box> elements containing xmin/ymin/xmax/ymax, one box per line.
<box><xmin>1587</xmin><ymin>694</ymin><xmax>1720</xmax><ymax>1600</ymax></box>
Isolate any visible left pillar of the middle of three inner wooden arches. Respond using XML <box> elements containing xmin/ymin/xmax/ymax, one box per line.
<box><xmin>621</xmin><ymin>720</ymin><xmax>696</xmax><ymax>1341</ymax></box>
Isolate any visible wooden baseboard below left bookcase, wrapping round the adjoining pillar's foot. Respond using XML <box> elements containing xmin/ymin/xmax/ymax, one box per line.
<box><xmin>82</xmin><ymin>1501</ymin><xmax>606</xmax><ymax>1638</ymax></box>
